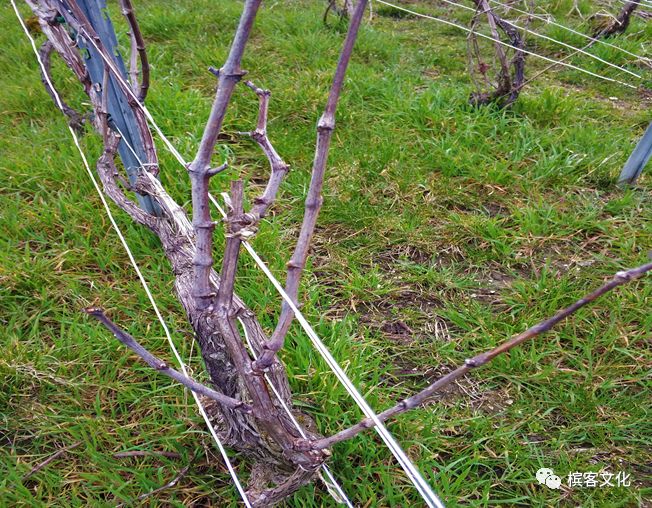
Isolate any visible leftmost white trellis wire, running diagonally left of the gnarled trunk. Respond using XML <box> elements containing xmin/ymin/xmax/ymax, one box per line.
<box><xmin>10</xmin><ymin>0</ymin><xmax>251</xmax><ymax>508</ymax></box>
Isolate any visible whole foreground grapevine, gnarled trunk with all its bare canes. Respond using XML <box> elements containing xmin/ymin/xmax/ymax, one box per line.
<box><xmin>22</xmin><ymin>0</ymin><xmax>652</xmax><ymax>506</ymax></box>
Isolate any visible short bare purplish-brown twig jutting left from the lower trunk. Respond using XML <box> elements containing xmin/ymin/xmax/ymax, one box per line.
<box><xmin>84</xmin><ymin>307</ymin><xmax>252</xmax><ymax>413</ymax></box>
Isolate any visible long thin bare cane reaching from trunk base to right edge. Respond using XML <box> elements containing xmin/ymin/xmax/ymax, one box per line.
<box><xmin>313</xmin><ymin>263</ymin><xmax>652</xmax><ymax>449</ymax></box>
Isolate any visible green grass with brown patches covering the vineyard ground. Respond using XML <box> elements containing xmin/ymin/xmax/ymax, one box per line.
<box><xmin>0</xmin><ymin>0</ymin><xmax>652</xmax><ymax>507</ymax></box>
